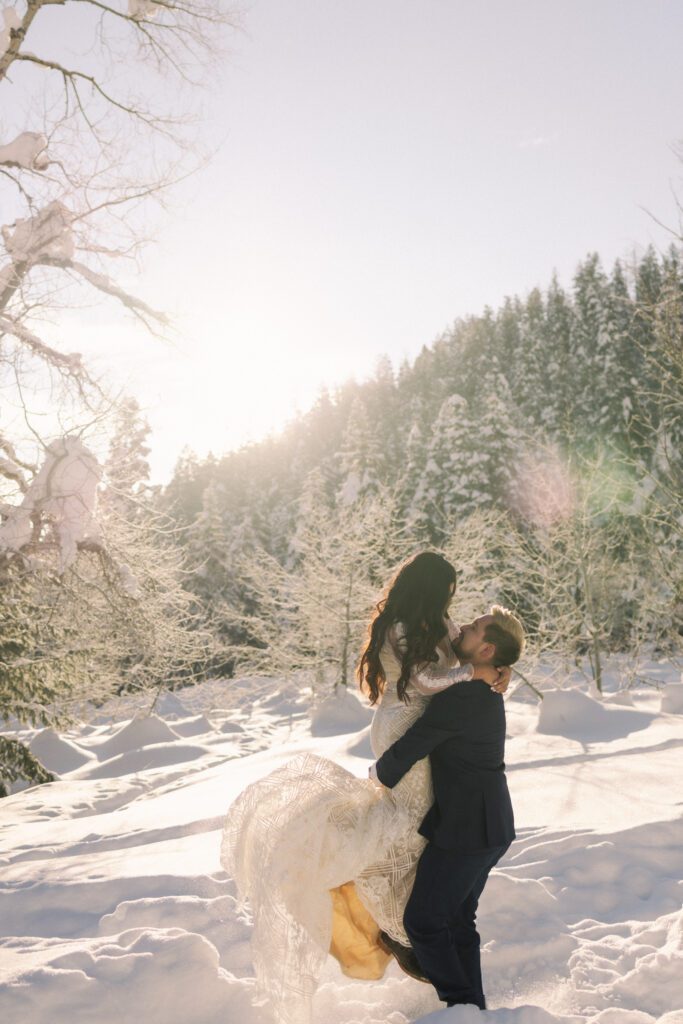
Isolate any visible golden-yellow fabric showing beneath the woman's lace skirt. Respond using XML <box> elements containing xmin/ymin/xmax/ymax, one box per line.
<box><xmin>330</xmin><ymin>882</ymin><xmax>391</xmax><ymax>981</ymax></box>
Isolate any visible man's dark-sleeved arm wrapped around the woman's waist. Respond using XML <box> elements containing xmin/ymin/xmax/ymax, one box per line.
<box><xmin>374</xmin><ymin>680</ymin><xmax>489</xmax><ymax>790</ymax></box>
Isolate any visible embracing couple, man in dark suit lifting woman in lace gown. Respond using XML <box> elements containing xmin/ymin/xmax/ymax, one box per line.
<box><xmin>221</xmin><ymin>551</ymin><xmax>524</xmax><ymax>1024</ymax></box>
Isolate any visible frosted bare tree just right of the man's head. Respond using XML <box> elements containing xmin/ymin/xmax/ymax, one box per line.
<box><xmin>500</xmin><ymin>449</ymin><xmax>671</xmax><ymax>691</ymax></box>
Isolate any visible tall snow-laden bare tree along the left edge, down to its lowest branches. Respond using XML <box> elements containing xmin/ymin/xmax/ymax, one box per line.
<box><xmin>0</xmin><ymin>0</ymin><xmax>239</xmax><ymax>783</ymax></box>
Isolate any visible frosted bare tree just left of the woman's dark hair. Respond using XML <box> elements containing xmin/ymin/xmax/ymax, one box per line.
<box><xmin>225</xmin><ymin>480</ymin><xmax>404</xmax><ymax>693</ymax></box>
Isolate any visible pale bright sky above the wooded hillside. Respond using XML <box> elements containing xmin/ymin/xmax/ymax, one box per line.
<box><xmin>29</xmin><ymin>0</ymin><xmax>683</xmax><ymax>480</ymax></box>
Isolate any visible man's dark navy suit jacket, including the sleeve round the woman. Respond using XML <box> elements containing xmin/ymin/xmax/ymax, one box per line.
<box><xmin>377</xmin><ymin>679</ymin><xmax>515</xmax><ymax>851</ymax></box>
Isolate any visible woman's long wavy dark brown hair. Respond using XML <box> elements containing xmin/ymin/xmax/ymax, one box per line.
<box><xmin>356</xmin><ymin>551</ymin><xmax>456</xmax><ymax>705</ymax></box>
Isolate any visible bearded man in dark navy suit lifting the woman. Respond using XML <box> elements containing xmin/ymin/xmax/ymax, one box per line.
<box><xmin>370</xmin><ymin>605</ymin><xmax>524</xmax><ymax>1010</ymax></box>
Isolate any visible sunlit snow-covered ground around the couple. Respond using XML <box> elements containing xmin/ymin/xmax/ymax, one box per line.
<box><xmin>0</xmin><ymin>664</ymin><xmax>683</xmax><ymax>1024</ymax></box>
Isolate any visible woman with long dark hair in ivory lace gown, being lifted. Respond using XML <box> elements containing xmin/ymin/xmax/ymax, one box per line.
<box><xmin>220</xmin><ymin>551</ymin><xmax>509</xmax><ymax>1024</ymax></box>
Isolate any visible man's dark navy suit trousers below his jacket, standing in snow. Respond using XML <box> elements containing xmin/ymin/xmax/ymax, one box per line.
<box><xmin>403</xmin><ymin>843</ymin><xmax>510</xmax><ymax>1010</ymax></box>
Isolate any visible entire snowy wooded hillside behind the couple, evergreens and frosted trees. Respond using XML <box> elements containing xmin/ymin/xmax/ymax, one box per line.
<box><xmin>161</xmin><ymin>245</ymin><xmax>683</xmax><ymax>686</ymax></box>
